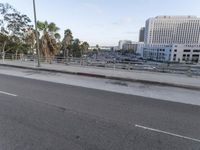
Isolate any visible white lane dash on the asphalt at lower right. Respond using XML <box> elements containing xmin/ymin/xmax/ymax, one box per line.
<box><xmin>135</xmin><ymin>124</ymin><xmax>200</xmax><ymax>143</ymax></box>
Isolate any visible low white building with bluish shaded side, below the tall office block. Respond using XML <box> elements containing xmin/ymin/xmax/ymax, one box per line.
<box><xmin>143</xmin><ymin>44</ymin><xmax>200</xmax><ymax>63</ymax></box>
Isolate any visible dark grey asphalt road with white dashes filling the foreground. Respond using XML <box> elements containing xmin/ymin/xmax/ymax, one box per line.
<box><xmin>0</xmin><ymin>75</ymin><xmax>200</xmax><ymax>150</ymax></box>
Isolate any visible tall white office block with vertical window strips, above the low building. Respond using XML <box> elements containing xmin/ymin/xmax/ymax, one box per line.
<box><xmin>144</xmin><ymin>16</ymin><xmax>200</xmax><ymax>45</ymax></box>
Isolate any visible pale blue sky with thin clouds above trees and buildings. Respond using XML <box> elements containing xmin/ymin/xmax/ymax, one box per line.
<box><xmin>1</xmin><ymin>0</ymin><xmax>200</xmax><ymax>46</ymax></box>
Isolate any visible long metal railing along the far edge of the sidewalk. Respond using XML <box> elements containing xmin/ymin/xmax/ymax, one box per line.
<box><xmin>0</xmin><ymin>54</ymin><xmax>200</xmax><ymax>76</ymax></box>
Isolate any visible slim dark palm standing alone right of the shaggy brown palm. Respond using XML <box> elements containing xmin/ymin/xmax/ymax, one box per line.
<box><xmin>62</xmin><ymin>29</ymin><xmax>73</xmax><ymax>57</ymax></box>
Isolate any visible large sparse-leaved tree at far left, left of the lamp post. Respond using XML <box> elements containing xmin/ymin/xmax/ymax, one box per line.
<box><xmin>0</xmin><ymin>3</ymin><xmax>31</xmax><ymax>60</ymax></box>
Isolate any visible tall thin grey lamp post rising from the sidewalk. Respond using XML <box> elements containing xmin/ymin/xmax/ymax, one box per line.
<box><xmin>33</xmin><ymin>0</ymin><xmax>40</xmax><ymax>67</ymax></box>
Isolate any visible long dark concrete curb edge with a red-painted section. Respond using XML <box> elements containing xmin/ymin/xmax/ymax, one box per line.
<box><xmin>0</xmin><ymin>64</ymin><xmax>200</xmax><ymax>91</ymax></box>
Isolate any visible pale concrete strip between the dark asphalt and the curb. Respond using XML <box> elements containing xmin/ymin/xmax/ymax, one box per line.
<box><xmin>0</xmin><ymin>66</ymin><xmax>200</xmax><ymax>106</ymax></box>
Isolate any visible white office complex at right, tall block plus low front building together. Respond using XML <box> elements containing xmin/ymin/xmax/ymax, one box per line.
<box><xmin>143</xmin><ymin>16</ymin><xmax>200</xmax><ymax>63</ymax></box>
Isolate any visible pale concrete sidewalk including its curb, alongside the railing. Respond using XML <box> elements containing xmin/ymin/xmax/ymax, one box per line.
<box><xmin>0</xmin><ymin>61</ymin><xmax>200</xmax><ymax>90</ymax></box>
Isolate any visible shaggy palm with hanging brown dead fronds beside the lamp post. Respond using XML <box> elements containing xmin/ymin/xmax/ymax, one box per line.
<box><xmin>37</xmin><ymin>21</ymin><xmax>59</xmax><ymax>63</ymax></box>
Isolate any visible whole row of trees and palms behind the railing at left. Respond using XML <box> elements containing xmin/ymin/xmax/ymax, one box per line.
<box><xmin>0</xmin><ymin>3</ymin><xmax>89</xmax><ymax>58</ymax></box>
